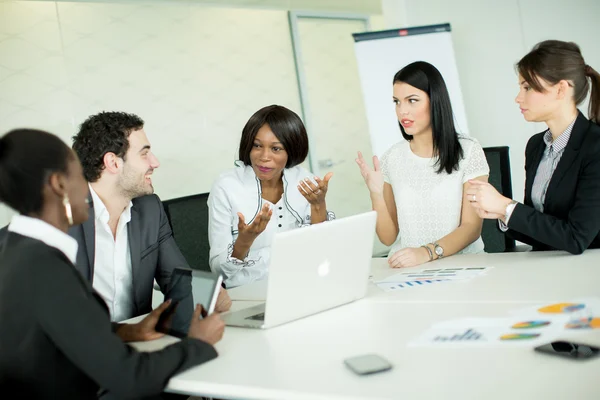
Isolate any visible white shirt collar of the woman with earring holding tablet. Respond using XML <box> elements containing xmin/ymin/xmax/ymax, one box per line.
<box><xmin>8</xmin><ymin>215</ymin><xmax>78</xmax><ymax>265</ymax></box>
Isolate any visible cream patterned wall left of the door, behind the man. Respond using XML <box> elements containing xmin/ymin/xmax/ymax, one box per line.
<box><xmin>0</xmin><ymin>0</ymin><xmax>380</xmax><ymax>226</ymax></box>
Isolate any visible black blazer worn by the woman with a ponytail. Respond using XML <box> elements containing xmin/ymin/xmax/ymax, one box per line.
<box><xmin>507</xmin><ymin>113</ymin><xmax>600</xmax><ymax>254</ymax></box>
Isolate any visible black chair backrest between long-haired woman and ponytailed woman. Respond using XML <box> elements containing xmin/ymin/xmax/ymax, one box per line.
<box><xmin>481</xmin><ymin>146</ymin><xmax>515</xmax><ymax>253</ymax></box>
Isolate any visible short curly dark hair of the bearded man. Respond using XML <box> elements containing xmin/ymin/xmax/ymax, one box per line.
<box><xmin>73</xmin><ymin>111</ymin><xmax>144</xmax><ymax>182</ymax></box>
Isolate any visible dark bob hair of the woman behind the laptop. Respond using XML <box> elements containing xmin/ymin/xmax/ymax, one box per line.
<box><xmin>239</xmin><ymin>105</ymin><xmax>308</xmax><ymax>168</ymax></box>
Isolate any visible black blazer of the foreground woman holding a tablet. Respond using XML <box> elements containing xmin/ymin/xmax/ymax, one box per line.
<box><xmin>0</xmin><ymin>232</ymin><xmax>217</xmax><ymax>399</ymax></box>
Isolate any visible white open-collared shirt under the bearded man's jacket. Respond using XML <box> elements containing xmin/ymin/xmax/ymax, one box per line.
<box><xmin>90</xmin><ymin>186</ymin><xmax>134</xmax><ymax>321</ymax></box>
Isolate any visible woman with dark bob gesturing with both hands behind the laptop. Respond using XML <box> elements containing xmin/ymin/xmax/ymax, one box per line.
<box><xmin>208</xmin><ymin>105</ymin><xmax>335</xmax><ymax>288</ymax></box>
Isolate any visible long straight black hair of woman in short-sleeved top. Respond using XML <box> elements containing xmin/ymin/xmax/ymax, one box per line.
<box><xmin>394</xmin><ymin>61</ymin><xmax>463</xmax><ymax>174</ymax></box>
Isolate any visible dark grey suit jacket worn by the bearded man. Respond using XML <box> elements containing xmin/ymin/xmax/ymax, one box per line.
<box><xmin>69</xmin><ymin>195</ymin><xmax>193</xmax><ymax>324</ymax></box>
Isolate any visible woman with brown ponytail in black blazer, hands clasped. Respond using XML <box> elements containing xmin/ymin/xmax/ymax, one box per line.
<box><xmin>466</xmin><ymin>40</ymin><xmax>600</xmax><ymax>254</ymax></box>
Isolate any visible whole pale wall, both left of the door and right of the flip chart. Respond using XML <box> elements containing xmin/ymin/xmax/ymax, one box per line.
<box><xmin>0</xmin><ymin>0</ymin><xmax>600</xmax><ymax>225</ymax></box>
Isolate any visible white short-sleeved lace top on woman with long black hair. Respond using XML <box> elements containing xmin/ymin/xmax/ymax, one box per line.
<box><xmin>381</xmin><ymin>135</ymin><xmax>490</xmax><ymax>255</ymax></box>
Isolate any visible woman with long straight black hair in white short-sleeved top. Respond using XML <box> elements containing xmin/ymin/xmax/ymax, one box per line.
<box><xmin>356</xmin><ymin>61</ymin><xmax>489</xmax><ymax>268</ymax></box>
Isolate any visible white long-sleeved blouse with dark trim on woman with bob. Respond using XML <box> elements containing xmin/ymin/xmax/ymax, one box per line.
<box><xmin>208</xmin><ymin>165</ymin><xmax>335</xmax><ymax>288</ymax></box>
